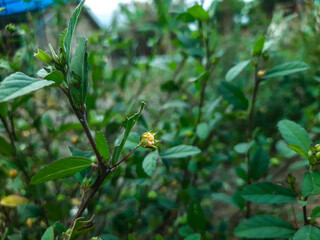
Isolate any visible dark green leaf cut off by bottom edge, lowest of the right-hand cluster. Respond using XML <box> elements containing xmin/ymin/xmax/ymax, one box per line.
<box><xmin>234</xmin><ymin>215</ymin><xmax>296</xmax><ymax>238</ymax></box>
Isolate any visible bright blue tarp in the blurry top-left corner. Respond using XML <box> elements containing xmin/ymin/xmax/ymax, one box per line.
<box><xmin>0</xmin><ymin>0</ymin><xmax>75</xmax><ymax>16</ymax></box>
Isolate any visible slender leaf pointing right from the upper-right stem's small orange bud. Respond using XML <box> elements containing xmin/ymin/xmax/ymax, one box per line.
<box><xmin>263</xmin><ymin>61</ymin><xmax>309</xmax><ymax>79</ymax></box>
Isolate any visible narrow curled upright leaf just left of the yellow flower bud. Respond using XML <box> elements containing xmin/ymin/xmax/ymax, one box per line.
<box><xmin>112</xmin><ymin>102</ymin><xmax>146</xmax><ymax>164</ymax></box>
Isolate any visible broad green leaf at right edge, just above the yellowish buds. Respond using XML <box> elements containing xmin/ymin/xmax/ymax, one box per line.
<box><xmin>278</xmin><ymin>120</ymin><xmax>311</xmax><ymax>155</ymax></box>
